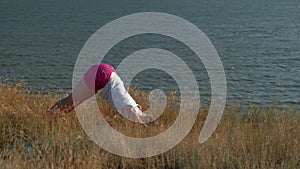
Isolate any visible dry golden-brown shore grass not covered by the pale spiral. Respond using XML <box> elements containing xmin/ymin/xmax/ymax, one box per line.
<box><xmin>0</xmin><ymin>83</ymin><xmax>300</xmax><ymax>169</ymax></box>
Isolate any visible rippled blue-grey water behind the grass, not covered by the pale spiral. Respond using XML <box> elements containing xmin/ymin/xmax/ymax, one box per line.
<box><xmin>0</xmin><ymin>0</ymin><xmax>300</xmax><ymax>107</ymax></box>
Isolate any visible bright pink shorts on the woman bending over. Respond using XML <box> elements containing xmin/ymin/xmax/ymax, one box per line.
<box><xmin>84</xmin><ymin>64</ymin><xmax>116</xmax><ymax>92</ymax></box>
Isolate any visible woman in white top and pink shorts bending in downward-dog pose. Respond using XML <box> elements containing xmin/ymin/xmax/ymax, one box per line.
<box><xmin>47</xmin><ymin>64</ymin><xmax>151</xmax><ymax>123</ymax></box>
